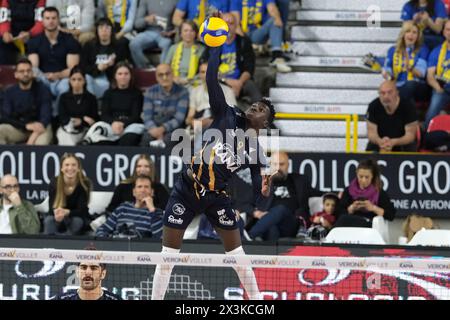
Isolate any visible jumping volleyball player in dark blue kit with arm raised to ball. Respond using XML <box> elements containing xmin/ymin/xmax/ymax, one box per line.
<box><xmin>152</xmin><ymin>14</ymin><xmax>275</xmax><ymax>300</ymax></box>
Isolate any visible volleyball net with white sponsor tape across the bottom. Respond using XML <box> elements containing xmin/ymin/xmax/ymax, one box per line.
<box><xmin>0</xmin><ymin>248</ymin><xmax>450</xmax><ymax>300</ymax></box>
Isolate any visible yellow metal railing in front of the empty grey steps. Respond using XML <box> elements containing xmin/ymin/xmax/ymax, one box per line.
<box><xmin>275</xmin><ymin>113</ymin><xmax>358</xmax><ymax>153</ymax></box>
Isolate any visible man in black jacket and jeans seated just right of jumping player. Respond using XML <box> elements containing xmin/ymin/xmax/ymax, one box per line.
<box><xmin>247</xmin><ymin>152</ymin><xmax>322</xmax><ymax>241</ymax></box>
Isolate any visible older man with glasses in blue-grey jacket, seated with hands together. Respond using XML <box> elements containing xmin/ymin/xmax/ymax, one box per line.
<box><xmin>141</xmin><ymin>64</ymin><xmax>189</xmax><ymax>147</ymax></box>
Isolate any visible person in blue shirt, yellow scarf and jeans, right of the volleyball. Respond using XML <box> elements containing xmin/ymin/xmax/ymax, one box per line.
<box><xmin>230</xmin><ymin>0</ymin><xmax>292</xmax><ymax>72</ymax></box>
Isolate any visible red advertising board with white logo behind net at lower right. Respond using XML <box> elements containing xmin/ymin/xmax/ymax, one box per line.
<box><xmin>251</xmin><ymin>246</ymin><xmax>450</xmax><ymax>300</ymax></box>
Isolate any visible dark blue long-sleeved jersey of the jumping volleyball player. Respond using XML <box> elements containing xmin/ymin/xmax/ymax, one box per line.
<box><xmin>190</xmin><ymin>47</ymin><xmax>267</xmax><ymax>206</ymax></box>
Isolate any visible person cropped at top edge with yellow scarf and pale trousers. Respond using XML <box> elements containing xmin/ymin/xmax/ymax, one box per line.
<box><xmin>96</xmin><ymin>0</ymin><xmax>138</xmax><ymax>39</ymax></box>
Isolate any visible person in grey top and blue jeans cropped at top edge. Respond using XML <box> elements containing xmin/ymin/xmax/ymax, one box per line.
<box><xmin>130</xmin><ymin>0</ymin><xmax>177</xmax><ymax>69</ymax></box>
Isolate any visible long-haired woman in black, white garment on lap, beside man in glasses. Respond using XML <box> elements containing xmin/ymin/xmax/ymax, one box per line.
<box><xmin>84</xmin><ymin>62</ymin><xmax>144</xmax><ymax>146</ymax></box>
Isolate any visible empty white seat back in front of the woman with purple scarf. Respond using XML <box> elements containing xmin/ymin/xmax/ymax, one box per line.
<box><xmin>324</xmin><ymin>227</ymin><xmax>386</xmax><ymax>245</ymax></box>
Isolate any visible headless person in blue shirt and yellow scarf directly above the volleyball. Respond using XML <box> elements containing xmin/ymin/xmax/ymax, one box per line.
<box><xmin>172</xmin><ymin>0</ymin><xmax>229</xmax><ymax>27</ymax></box>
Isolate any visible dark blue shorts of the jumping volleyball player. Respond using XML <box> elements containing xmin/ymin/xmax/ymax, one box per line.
<box><xmin>163</xmin><ymin>173</ymin><xmax>238</xmax><ymax>230</ymax></box>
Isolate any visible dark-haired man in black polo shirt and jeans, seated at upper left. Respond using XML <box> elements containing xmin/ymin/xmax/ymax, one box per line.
<box><xmin>28</xmin><ymin>7</ymin><xmax>80</xmax><ymax>116</ymax></box>
